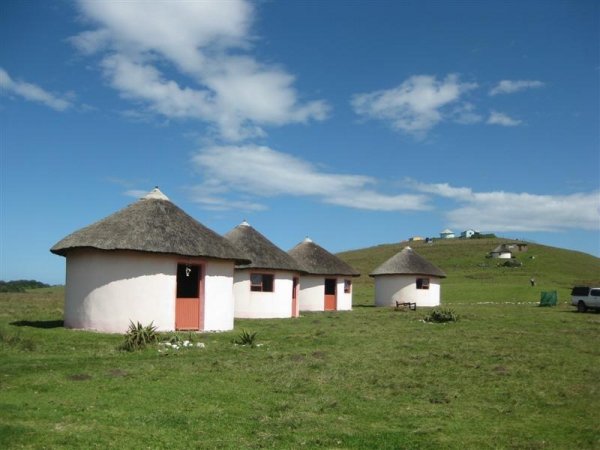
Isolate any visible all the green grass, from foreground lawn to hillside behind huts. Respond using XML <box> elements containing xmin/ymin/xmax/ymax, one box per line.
<box><xmin>0</xmin><ymin>243</ymin><xmax>600</xmax><ymax>449</ymax></box>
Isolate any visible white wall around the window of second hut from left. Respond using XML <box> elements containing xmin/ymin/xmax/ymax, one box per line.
<box><xmin>233</xmin><ymin>269</ymin><xmax>294</xmax><ymax>319</ymax></box>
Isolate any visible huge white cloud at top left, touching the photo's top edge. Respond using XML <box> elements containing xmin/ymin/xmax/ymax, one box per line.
<box><xmin>71</xmin><ymin>0</ymin><xmax>329</xmax><ymax>141</ymax></box>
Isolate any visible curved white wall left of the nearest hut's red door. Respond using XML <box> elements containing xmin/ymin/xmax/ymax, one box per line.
<box><xmin>64</xmin><ymin>249</ymin><xmax>177</xmax><ymax>333</ymax></box>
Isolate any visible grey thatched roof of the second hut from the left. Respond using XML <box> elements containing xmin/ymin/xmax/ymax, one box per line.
<box><xmin>225</xmin><ymin>221</ymin><xmax>301</xmax><ymax>272</ymax></box>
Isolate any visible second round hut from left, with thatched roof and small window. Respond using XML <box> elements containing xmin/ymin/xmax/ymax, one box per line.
<box><xmin>225</xmin><ymin>221</ymin><xmax>300</xmax><ymax>319</ymax></box>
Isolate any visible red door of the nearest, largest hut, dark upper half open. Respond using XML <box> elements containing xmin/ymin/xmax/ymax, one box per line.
<box><xmin>175</xmin><ymin>264</ymin><xmax>204</xmax><ymax>330</ymax></box>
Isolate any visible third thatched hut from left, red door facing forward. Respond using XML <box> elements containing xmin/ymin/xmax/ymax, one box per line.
<box><xmin>288</xmin><ymin>238</ymin><xmax>360</xmax><ymax>311</ymax></box>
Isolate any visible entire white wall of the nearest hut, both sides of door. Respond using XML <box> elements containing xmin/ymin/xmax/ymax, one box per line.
<box><xmin>64</xmin><ymin>249</ymin><xmax>233</xmax><ymax>333</ymax></box>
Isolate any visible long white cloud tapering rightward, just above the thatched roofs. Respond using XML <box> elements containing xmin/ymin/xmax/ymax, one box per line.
<box><xmin>193</xmin><ymin>145</ymin><xmax>429</xmax><ymax>211</ymax></box>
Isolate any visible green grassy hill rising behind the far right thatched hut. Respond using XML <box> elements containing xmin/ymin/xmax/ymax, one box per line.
<box><xmin>338</xmin><ymin>238</ymin><xmax>600</xmax><ymax>305</ymax></box>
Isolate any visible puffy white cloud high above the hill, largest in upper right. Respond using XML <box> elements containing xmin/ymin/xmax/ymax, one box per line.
<box><xmin>352</xmin><ymin>74</ymin><xmax>479</xmax><ymax>136</ymax></box>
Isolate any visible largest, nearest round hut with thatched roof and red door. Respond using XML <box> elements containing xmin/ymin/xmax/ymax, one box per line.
<box><xmin>50</xmin><ymin>188</ymin><xmax>248</xmax><ymax>333</ymax></box>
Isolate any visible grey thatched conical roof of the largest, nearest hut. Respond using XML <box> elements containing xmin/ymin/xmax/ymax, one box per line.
<box><xmin>50</xmin><ymin>188</ymin><xmax>248</xmax><ymax>263</ymax></box>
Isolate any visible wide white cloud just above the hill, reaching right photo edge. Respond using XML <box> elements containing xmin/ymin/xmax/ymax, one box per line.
<box><xmin>410</xmin><ymin>181</ymin><xmax>600</xmax><ymax>232</ymax></box>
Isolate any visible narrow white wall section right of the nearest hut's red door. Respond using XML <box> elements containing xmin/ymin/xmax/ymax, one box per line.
<box><xmin>204</xmin><ymin>261</ymin><xmax>234</xmax><ymax>331</ymax></box>
